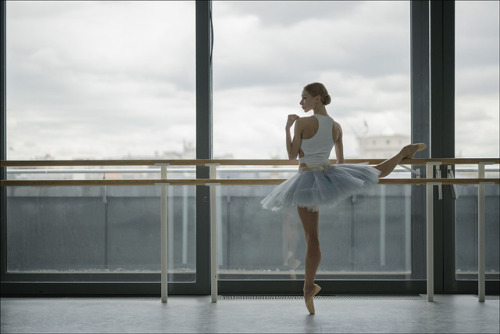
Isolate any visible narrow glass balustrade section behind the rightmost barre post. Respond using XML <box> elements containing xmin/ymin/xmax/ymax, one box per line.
<box><xmin>455</xmin><ymin>165</ymin><xmax>500</xmax><ymax>280</ymax></box>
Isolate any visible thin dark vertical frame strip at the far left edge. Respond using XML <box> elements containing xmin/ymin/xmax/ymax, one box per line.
<box><xmin>0</xmin><ymin>1</ymin><xmax>7</xmax><ymax>277</ymax></box>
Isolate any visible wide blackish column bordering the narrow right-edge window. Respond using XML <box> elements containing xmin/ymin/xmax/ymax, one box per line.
<box><xmin>430</xmin><ymin>1</ymin><xmax>455</xmax><ymax>293</ymax></box>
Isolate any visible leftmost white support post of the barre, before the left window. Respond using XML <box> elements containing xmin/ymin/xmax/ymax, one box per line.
<box><xmin>157</xmin><ymin>163</ymin><xmax>169</xmax><ymax>303</ymax></box>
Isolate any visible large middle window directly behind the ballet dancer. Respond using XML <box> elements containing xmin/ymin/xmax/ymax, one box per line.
<box><xmin>213</xmin><ymin>1</ymin><xmax>415</xmax><ymax>280</ymax></box>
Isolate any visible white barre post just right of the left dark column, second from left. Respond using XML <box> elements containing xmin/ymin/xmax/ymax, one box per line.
<box><xmin>206</xmin><ymin>163</ymin><xmax>220</xmax><ymax>303</ymax></box>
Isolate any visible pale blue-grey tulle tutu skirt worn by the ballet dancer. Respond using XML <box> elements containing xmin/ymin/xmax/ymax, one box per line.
<box><xmin>261</xmin><ymin>164</ymin><xmax>380</xmax><ymax>211</ymax></box>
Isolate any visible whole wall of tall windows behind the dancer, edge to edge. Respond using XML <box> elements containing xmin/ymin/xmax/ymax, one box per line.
<box><xmin>1</xmin><ymin>1</ymin><xmax>499</xmax><ymax>294</ymax></box>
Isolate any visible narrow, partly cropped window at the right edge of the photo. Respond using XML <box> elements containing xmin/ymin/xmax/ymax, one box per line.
<box><xmin>455</xmin><ymin>1</ymin><xmax>500</xmax><ymax>280</ymax></box>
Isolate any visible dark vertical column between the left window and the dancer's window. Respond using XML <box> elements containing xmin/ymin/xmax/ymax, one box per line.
<box><xmin>193</xmin><ymin>0</ymin><xmax>213</xmax><ymax>294</ymax></box>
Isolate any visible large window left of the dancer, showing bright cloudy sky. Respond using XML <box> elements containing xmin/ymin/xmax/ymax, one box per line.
<box><xmin>6</xmin><ymin>1</ymin><xmax>196</xmax><ymax>281</ymax></box>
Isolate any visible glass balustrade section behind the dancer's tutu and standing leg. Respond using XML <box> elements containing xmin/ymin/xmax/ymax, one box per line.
<box><xmin>218</xmin><ymin>167</ymin><xmax>425</xmax><ymax>280</ymax></box>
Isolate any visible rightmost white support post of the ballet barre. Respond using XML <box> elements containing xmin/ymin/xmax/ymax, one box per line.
<box><xmin>477</xmin><ymin>162</ymin><xmax>491</xmax><ymax>303</ymax></box>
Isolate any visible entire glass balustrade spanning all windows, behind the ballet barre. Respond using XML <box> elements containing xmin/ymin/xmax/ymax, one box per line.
<box><xmin>2</xmin><ymin>160</ymin><xmax>500</xmax><ymax>282</ymax></box>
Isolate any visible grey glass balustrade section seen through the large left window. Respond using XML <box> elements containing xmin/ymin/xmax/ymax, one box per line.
<box><xmin>7</xmin><ymin>167</ymin><xmax>196</xmax><ymax>282</ymax></box>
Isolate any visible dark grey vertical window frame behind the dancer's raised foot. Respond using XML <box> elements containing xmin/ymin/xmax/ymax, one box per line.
<box><xmin>410</xmin><ymin>1</ymin><xmax>430</xmax><ymax>279</ymax></box>
